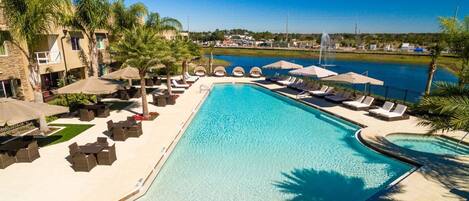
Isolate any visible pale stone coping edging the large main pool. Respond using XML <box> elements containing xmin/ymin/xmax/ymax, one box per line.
<box><xmin>119</xmin><ymin>81</ymin><xmax>423</xmax><ymax>201</ymax></box>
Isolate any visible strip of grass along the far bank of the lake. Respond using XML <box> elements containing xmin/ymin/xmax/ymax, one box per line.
<box><xmin>204</xmin><ymin>48</ymin><xmax>460</xmax><ymax>72</ymax></box>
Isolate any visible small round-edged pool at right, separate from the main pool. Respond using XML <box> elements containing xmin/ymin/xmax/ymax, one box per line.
<box><xmin>386</xmin><ymin>134</ymin><xmax>469</xmax><ymax>156</ymax></box>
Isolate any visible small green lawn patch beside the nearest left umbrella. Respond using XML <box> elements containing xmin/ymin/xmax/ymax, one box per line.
<box><xmin>37</xmin><ymin>124</ymin><xmax>94</xmax><ymax>147</ymax></box>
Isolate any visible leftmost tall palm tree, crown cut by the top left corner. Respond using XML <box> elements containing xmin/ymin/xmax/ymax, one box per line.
<box><xmin>1</xmin><ymin>0</ymin><xmax>68</xmax><ymax>102</ymax></box>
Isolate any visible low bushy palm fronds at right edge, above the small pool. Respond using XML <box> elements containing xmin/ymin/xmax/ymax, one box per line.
<box><xmin>417</xmin><ymin>82</ymin><xmax>469</xmax><ymax>142</ymax></box>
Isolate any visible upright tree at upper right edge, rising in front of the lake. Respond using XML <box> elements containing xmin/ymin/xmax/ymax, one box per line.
<box><xmin>440</xmin><ymin>16</ymin><xmax>469</xmax><ymax>87</ymax></box>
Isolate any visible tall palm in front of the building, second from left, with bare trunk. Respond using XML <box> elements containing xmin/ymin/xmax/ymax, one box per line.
<box><xmin>65</xmin><ymin>0</ymin><xmax>111</xmax><ymax>76</ymax></box>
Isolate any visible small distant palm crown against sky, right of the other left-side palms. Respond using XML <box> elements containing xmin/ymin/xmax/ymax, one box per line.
<box><xmin>145</xmin><ymin>12</ymin><xmax>182</xmax><ymax>32</ymax></box>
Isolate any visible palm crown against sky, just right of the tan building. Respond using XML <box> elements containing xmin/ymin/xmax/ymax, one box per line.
<box><xmin>111</xmin><ymin>0</ymin><xmax>148</xmax><ymax>40</ymax></box>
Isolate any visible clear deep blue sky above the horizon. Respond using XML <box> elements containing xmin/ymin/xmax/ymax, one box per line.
<box><xmin>125</xmin><ymin>0</ymin><xmax>469</xmax><ymax>33</ymax></box>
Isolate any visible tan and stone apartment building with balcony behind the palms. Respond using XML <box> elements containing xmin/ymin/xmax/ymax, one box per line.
<box><xmin>0</xmin><ymin>4</ymin><xmax>110</xmax><ymax>100</ymax></box>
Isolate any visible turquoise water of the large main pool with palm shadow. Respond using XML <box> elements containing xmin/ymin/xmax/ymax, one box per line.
<box><xmin>141</xmin><ymin>84</ymin><xmax>412</xmax><ymax>201</ymax></box>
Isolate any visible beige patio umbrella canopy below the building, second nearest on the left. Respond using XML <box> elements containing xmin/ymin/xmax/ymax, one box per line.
<box><xmin>57</xmin><ymin>77</ymin><xmax>125</xmax><ymax>95</ymax></box>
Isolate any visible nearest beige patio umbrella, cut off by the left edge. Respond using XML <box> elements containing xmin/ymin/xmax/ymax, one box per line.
<box><xmin>0</xmin><ymin>98</ymin><xmax>69</xmax><ymax>131</ymax></box>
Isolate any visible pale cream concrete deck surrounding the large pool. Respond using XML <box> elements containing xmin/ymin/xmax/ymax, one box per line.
<box><xmin>0</xmin><ymin>77</ymin><xmax>469</xmax><ymax>201</ymax></box>
